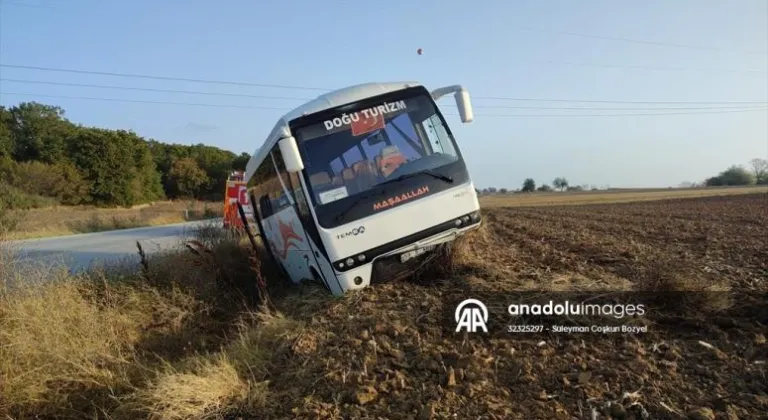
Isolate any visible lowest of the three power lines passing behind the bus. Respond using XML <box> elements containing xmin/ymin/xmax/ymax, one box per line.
<box><xmin>0</xmin><ymin>92</ymin><xmax>768</xmax><ymax>118</ymax></box>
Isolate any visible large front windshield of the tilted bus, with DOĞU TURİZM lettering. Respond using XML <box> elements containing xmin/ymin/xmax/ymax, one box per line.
<box><xmin>296</xmin><ymin>94</ymin><xmax>463</xmax><ymax>207</ymax></box>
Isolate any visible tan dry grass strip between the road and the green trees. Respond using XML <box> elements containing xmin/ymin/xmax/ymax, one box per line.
<box><xmin>6</xmin><ymin>201</ymin><xmax>223</xmax><ymax>239</ymax></box>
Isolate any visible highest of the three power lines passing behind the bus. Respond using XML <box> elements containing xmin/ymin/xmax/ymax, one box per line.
<box><xmin>0</xmin><ymin>64</ymin><xmax>768</xmax><ymax>105</ymax></box>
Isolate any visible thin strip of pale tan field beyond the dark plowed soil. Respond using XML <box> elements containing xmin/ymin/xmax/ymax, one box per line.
<box><xmin>480</xmin><ymin>185</ymin><xmax>768</xmax><ymax>208</ymax></box>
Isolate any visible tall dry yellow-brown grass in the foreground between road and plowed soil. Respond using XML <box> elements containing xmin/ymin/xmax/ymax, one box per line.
<box><xmin>0</xmin><ymin>220</ymin><xmax>296</xmax><ymax>419</ymax></box>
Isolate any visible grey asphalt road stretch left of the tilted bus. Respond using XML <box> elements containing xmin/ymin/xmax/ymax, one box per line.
<box><xmin>10</xmin><ymin>219</ymin><xmax>221</xmax><ymax>272</ymax></box>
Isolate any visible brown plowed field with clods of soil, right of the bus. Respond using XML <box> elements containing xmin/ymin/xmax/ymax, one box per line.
<box><xmin>256</xmin><ymin>194</ymin><xmax>768</xmax><ymax>419</ymax></box>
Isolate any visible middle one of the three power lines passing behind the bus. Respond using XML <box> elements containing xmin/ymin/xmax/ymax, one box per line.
<box><xmin>0</xmin><ymin>78</ymin><xmax>768</xmax><ymax>111</ymax></box>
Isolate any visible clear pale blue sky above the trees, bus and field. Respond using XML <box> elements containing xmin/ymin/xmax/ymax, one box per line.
<box><xmin>0</xmin><ymin>0</ymin><xmax>768</xmax><ymax>189</ymax></box>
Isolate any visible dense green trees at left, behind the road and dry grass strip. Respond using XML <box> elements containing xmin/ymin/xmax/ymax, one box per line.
<box><xmin>0</xmin><ymin>102</ymin><xmax>250</xmax><ymax>208</ymax></box>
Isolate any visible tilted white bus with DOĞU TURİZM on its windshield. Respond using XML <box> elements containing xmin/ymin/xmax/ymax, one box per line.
<box><xmin>244</xmin><ymin>82</ymin><xmax>481</xmax><ymax>296</ymax></box>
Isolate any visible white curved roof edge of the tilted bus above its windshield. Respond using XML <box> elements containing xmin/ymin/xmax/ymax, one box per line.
<box><xmin>245</xmin><ymin>82</ymin><xmax>421</xmax><ymax>181</ymax></box>
